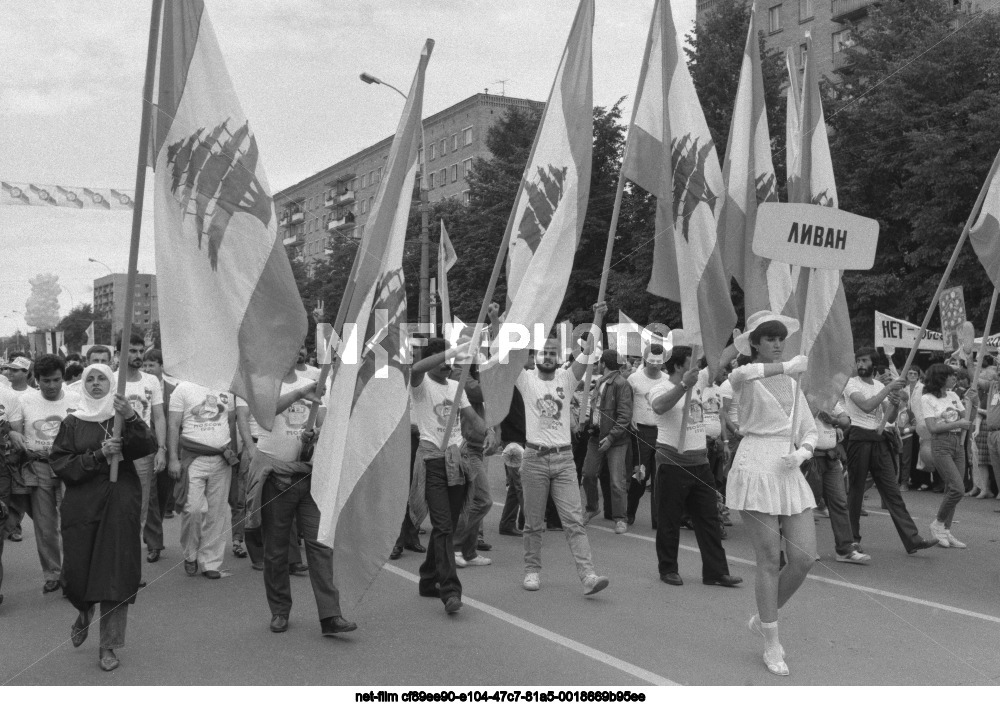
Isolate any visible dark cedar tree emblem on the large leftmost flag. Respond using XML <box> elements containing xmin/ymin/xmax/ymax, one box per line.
<box><xmin>167</xmin><ymin>120</ymin><xmax>271</xmax><ymax>271</ymax></box>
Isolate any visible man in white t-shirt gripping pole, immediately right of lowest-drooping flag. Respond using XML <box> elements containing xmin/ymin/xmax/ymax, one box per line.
<box><xmin>410</xmin><ymin>338</ymin><xmax>486</xmax><ymax>615</ymax></box>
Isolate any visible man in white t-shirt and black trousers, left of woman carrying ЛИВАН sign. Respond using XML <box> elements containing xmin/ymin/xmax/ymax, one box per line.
<box><xmin>649</xmin><ymin>339</ymin><xmax>743</xmax><ymax>588</ymax></box>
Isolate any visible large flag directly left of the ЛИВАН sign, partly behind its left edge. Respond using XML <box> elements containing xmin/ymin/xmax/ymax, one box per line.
<box><xmin>719</xmin><ymin>8</ymin><xmax>792</xmax><ymax>317</ymax></box>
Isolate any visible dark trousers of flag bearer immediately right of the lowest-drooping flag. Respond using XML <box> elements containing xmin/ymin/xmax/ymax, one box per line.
<box><xmin>420</xmin><ymin>458</ymin><xmax>465</xmax><ymax>602</ymax></box>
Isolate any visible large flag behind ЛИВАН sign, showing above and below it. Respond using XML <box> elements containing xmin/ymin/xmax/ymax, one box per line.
<box><xmin>795</xmin><ymin>41</ymin><xmax>854</xmax><ymax>414</ymax></box>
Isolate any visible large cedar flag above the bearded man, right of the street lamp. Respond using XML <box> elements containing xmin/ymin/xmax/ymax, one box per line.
<box><xmin>480</xmin><ymin>0</ymin><xmax>594</xmax><ymax>426</ymax></box>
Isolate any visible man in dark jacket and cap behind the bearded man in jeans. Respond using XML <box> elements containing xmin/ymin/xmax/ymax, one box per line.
<box><xmin>583</xmin><ymin>349</ymin><xmax>632</xmax><ymax>534</ymax></box>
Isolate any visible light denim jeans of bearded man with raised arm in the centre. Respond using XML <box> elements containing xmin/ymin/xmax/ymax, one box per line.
<box><xmin>521</xmin><ymin>449</ymin><xmax>594</xmax><ymax>580</ymax></box>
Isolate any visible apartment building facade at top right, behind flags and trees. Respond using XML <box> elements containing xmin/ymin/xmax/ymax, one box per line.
<box><xmin>697</xmin><ymin>0</ymin><xmax>984</xmax><ymax>76</ymax></box>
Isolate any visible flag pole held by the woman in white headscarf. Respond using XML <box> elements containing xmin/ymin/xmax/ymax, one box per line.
<box><xmin>111</xmin><ymin>0</ymin><xmax>163</xmax><ymax>483</ymax></box>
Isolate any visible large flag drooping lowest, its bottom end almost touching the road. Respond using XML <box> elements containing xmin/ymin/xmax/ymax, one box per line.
<box><xmin>312</xmin><ymin>39</ymin><xmax>434</xmax><ymax>602</ymax></box>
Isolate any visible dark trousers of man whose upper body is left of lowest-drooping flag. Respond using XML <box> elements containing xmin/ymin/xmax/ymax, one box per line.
<box><xmin>261</xmin><ymin>475</ymin><xmax>341</xmax><ymax>620</ymax></box>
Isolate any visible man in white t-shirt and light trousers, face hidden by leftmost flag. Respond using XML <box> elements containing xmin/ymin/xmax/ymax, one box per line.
<box><xmin>167</xmin><ymin>382</ymin><xmax>236</xmax><ymax>579</ymax></box>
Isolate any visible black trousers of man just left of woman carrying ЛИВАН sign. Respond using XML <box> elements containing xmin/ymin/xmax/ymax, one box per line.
<box><xmin>655</xmin><ymin>457</ymin><xmax>729</xmax><ymax>579</ymax></box>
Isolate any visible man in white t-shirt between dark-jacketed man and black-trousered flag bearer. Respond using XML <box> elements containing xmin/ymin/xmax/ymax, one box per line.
<box><xmin>625</xmin><ymin>343</ymin><xmax>665</xmax><ymax>530</ymax></box>
